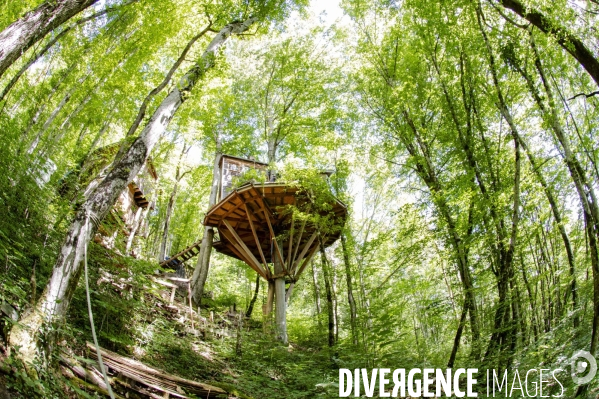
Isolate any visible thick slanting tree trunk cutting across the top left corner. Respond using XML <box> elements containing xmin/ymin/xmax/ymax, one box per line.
<box><xmin>0</xmin><ymin>0</ymin><xmax>98</xmax><ymax>77</ymax></box>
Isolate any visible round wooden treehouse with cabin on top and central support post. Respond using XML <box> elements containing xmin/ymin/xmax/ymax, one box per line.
<box><xmin>204</xmin><ymin>157</ymin><xmax>347</xmax><ymax>343</ymax></box>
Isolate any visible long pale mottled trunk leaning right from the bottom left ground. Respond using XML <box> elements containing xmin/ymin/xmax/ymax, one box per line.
<box><xmin>10</xmin><ymin>17</ymin><xmax>256</xmax><ymax>363</ymax></box>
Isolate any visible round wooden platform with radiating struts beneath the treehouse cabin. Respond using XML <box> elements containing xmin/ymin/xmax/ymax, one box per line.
<box><xmin>204</xmin><ymin>183</ymin><xmax>347</xmax><ymax>281</ymax></box>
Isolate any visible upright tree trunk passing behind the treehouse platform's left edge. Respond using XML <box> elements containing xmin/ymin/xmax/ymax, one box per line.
<box><xmin>191</xmin><ymin>145</ymin><xmax>222</xmax><ymax>306</ymax></box>
